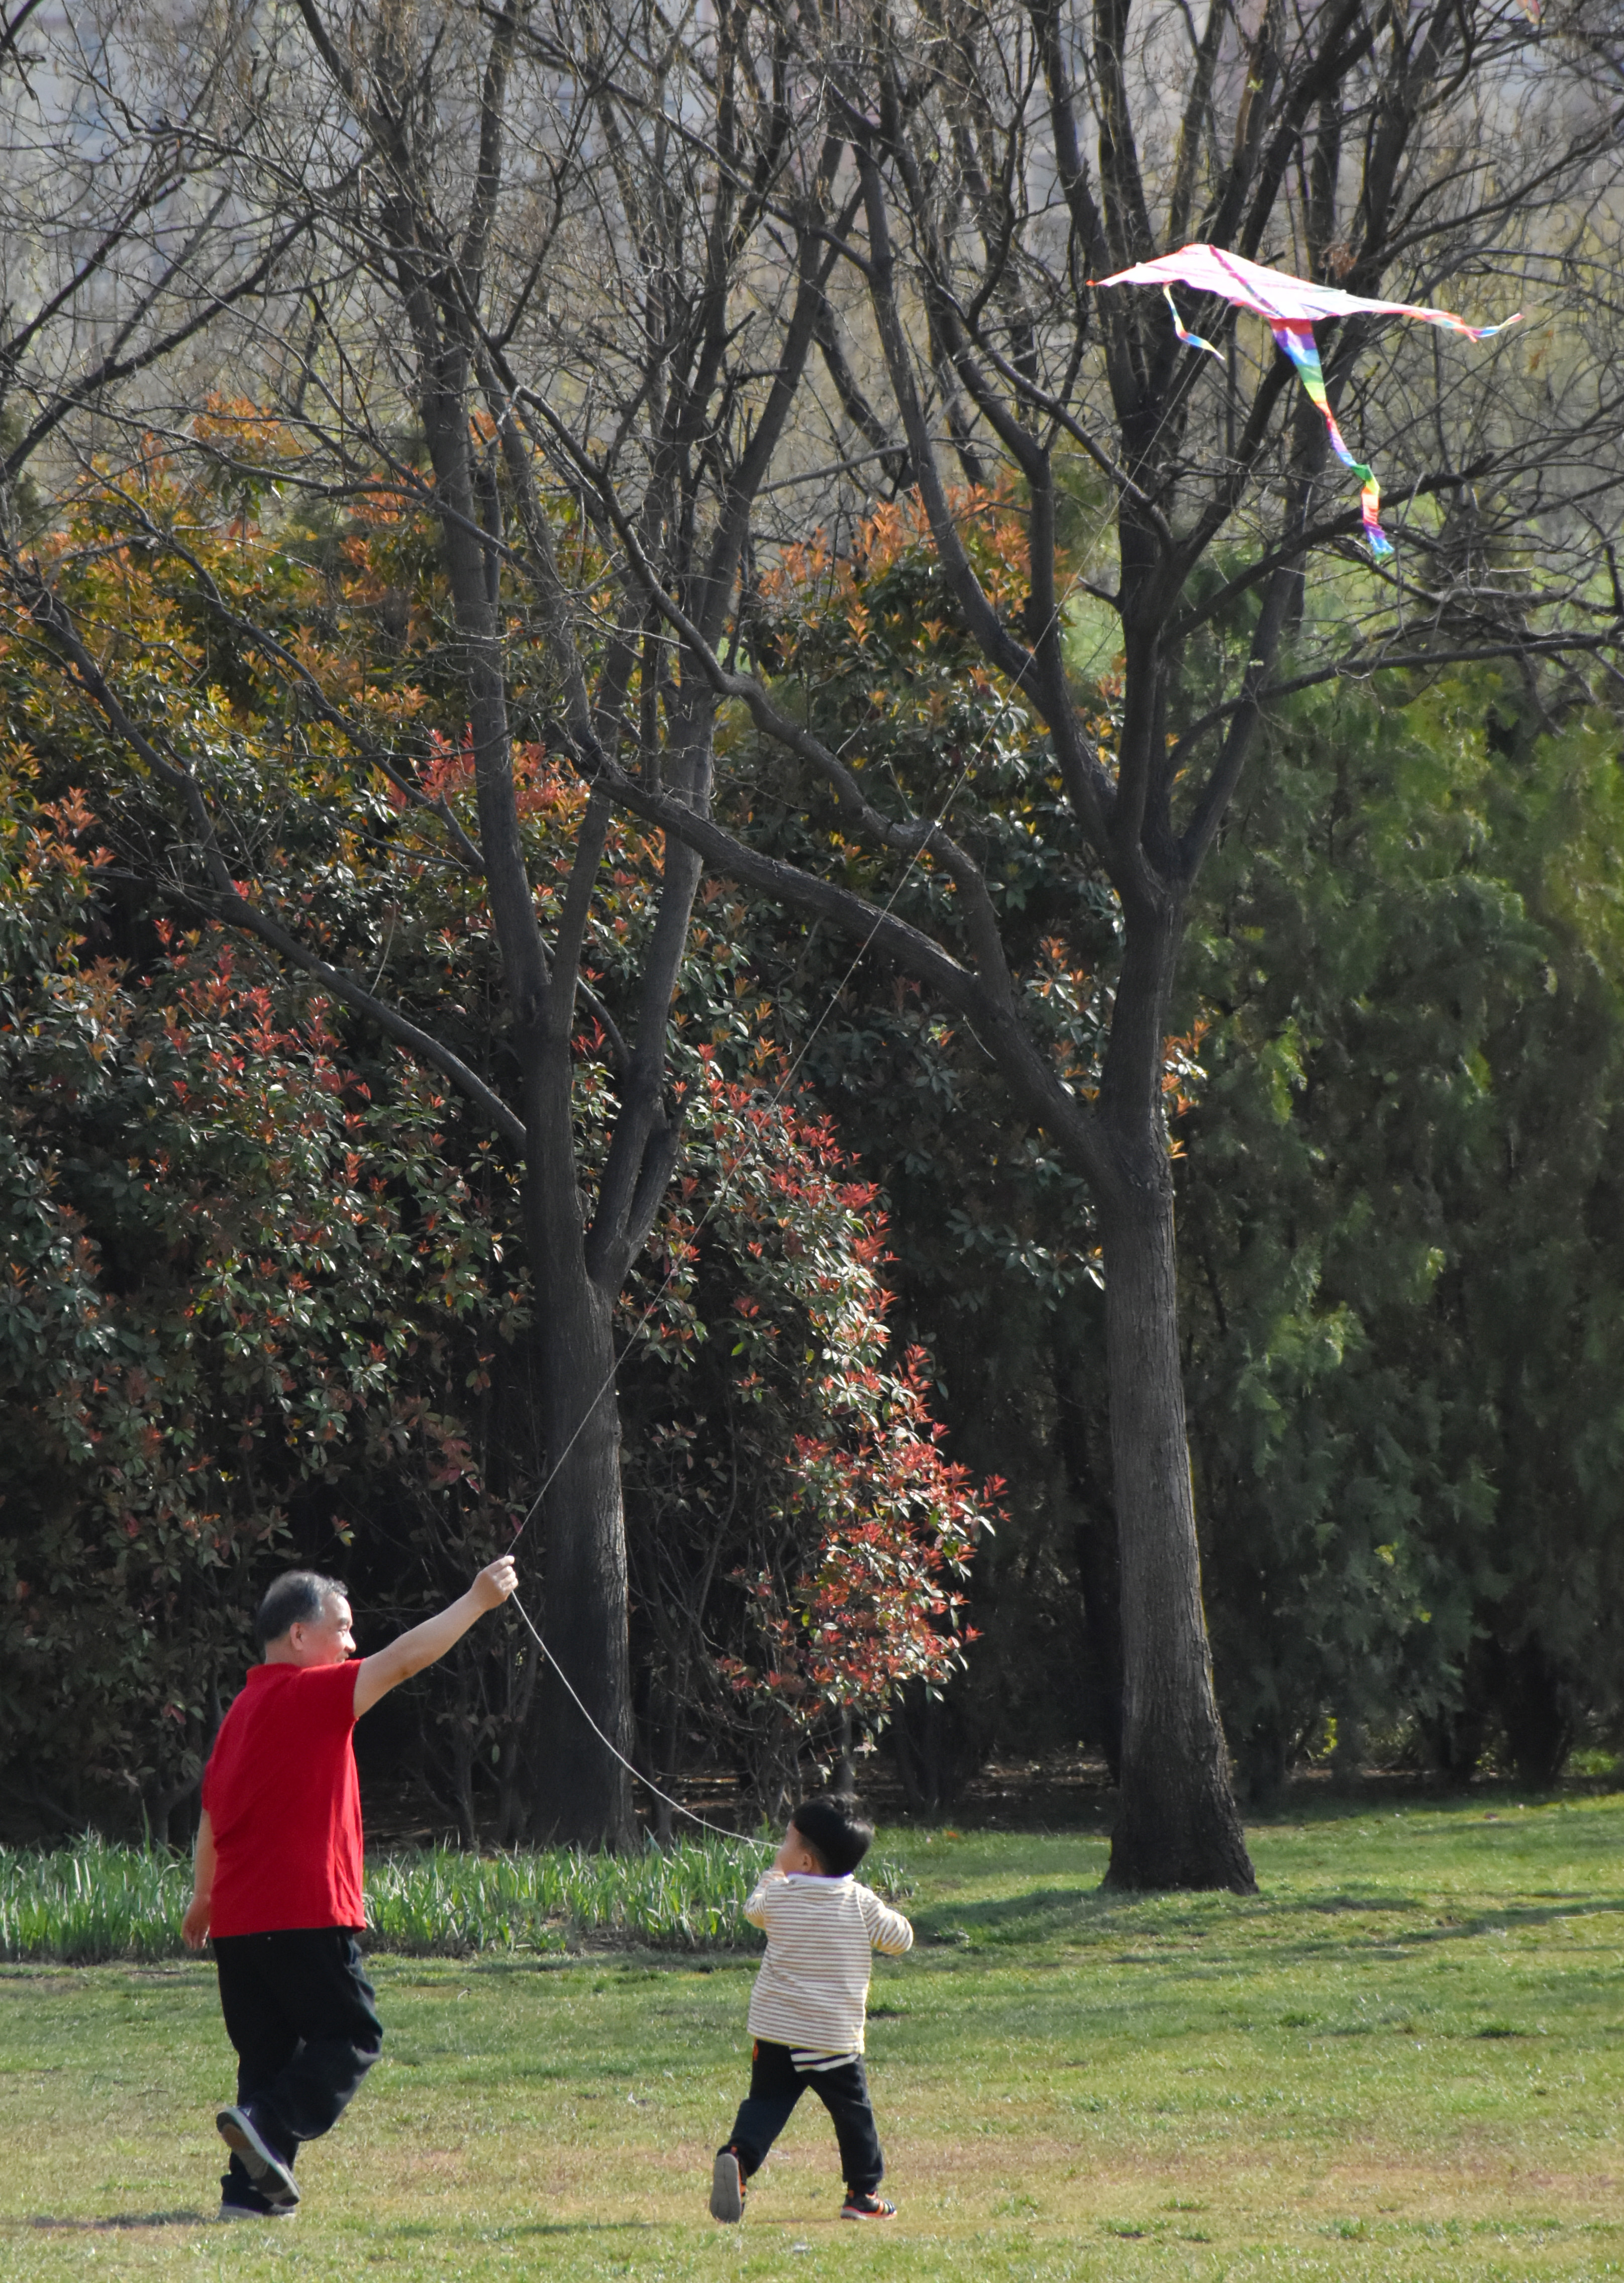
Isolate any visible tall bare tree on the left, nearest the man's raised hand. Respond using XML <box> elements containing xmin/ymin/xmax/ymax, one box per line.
<box><xmin>18</xmin><ymin>0</ymin><xmax>836</xmax><ymax>1845</ymax></box>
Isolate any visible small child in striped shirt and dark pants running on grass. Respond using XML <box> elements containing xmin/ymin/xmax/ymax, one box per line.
<box><xmin>710</xmin><ymin>1795</ymin><xmax>914</xmax><ymax>2219</ymax></box>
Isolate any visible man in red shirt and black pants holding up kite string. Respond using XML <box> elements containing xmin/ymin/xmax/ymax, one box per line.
<box><xmin>183</xmin><ymin>1554</ymin><xmax>519</xmax><ymax>2219</ymax></box>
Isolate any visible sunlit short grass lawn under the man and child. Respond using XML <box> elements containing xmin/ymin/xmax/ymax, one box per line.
<box><xmin>0</xmin><ymin>1797</ymin><xmax>1624</xmax><ymax>2283</ymax></box>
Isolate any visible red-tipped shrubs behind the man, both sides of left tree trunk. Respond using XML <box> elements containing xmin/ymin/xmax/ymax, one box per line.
<box><xmin>0</xmin><ymin>459</ymin><xmax>996</xmax><ymax>1842</ymax></box>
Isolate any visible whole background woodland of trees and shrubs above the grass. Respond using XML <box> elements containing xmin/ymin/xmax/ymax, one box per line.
<box><xmin>0</xmin><ymin>0</ymin><xmax>1624</xmax><ymax>1853</ymax></box>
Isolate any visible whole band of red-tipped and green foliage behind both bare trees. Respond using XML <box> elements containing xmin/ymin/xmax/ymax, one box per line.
<box><xmin>0</xmin><ymin>445</ymin><xmax>1624</xmax><ymax>1840</ymax></box>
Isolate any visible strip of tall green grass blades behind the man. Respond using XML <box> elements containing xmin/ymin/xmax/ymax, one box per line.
<box><xmin>0</xmin><ymin>1840</ymin><xmax>761</xmax><ymax>1965</ymax></box>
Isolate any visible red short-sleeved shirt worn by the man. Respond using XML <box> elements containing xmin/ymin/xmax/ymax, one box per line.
<box><xmin>204</xmin><ymin>1665</ymin><xmax>365</xmax><ymax>1934</ymax></box>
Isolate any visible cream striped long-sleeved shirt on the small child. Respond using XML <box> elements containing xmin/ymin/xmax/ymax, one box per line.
<box><xmin>745</xmin><ymin>1872</ymin><xmax>914</xmax><ymax>2055</ymax></box>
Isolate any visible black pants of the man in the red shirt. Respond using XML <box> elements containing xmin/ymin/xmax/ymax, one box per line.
<box><xmin>215</xmin><ymin>1927</ymin><xmax>384</xmax><ymax>2201</ymax></box>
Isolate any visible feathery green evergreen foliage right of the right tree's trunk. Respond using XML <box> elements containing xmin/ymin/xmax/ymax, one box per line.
<box><xmin>1181</xmin><ymin>676</ymin><xmax>1624</xmax><ymax>1792</ymax></box>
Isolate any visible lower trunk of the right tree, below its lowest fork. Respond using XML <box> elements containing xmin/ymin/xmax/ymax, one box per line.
<box><xmin>1103</xmin><ymin>1155</ymin><xmax>1256</xmax><ymax>1895</ymax></box>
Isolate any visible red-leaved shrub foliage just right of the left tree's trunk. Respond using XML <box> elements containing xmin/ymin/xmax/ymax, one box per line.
<box><xmin>651</xmin><ymin>1046</ymin><xmax>1003</xmax><ymax>1728</ymax></box>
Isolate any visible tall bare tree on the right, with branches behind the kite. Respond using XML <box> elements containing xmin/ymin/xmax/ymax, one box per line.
<box><xmin>551</xmin><ymin>0</ymin><xmax>1619</xmax><ymax>1890</ymax></box>
